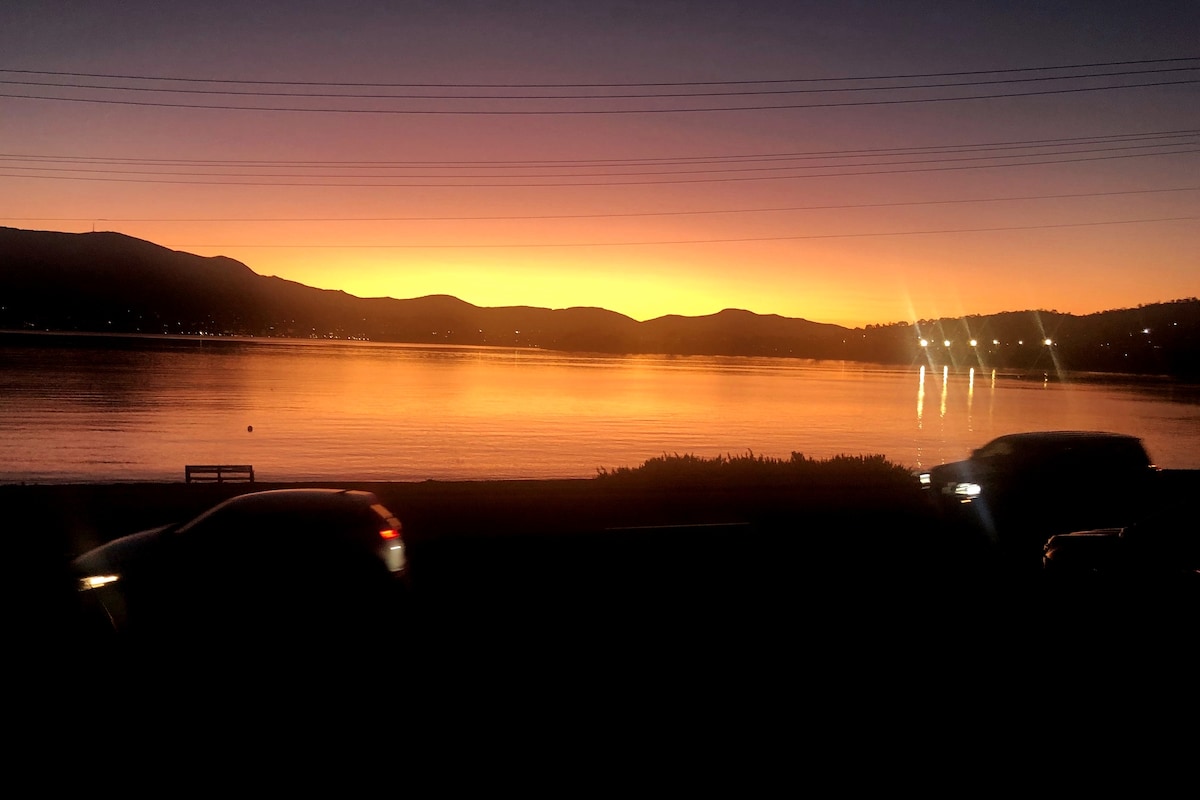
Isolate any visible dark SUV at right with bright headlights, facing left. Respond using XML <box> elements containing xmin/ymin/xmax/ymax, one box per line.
<box><xmin>918</xmin><ymin>431</ymin><xmax>1158</xmax><ymax>569</ymax></box>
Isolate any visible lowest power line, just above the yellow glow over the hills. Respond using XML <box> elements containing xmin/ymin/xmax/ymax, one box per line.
<box><xmin>162</xmin><ymin>216</ymin><xmax>1200</xmax><ymax>249</ymax></box>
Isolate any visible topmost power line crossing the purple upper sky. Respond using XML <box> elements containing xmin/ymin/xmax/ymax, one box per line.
<box><xmin>0</xmin><ymin>55</ymin><xmax>1200</xmax><ymax>89</ymax></box>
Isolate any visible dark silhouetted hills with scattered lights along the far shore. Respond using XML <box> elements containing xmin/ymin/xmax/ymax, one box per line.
<box><xmin>0</xmin><ymin>228</ymin><xmax>1200</xmax><ymax>375</ymax></box>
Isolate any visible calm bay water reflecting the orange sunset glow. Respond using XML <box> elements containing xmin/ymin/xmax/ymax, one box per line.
<box><xmin>0</xmin><ymin>336</ymin><xmax>1200</xmax><ymax>483</ymax></box>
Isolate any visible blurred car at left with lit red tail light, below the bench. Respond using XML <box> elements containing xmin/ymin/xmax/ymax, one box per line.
<box><xmin>72</xmin><ymin>488</ymin><xmax>408</xmax><ymax>637</ymax></box>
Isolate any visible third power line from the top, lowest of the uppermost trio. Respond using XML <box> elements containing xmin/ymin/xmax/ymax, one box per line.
<box><xmin>0</xmin><ymin>78</ymin><xmax>1200</xmax><ymax>116</ymax></box>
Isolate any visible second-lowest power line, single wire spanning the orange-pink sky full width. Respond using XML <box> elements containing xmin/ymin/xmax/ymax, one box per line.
<box><xmin>2</xmin><ymin>186</ymin><xmax>1200</xmax><ymax>222</ymax></box>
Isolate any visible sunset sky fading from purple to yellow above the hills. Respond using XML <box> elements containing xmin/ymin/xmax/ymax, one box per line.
<box><xmin>0</xmin><ymin>0</ymin><xmax>1200</xmax><ymax>326</ymax></box>
